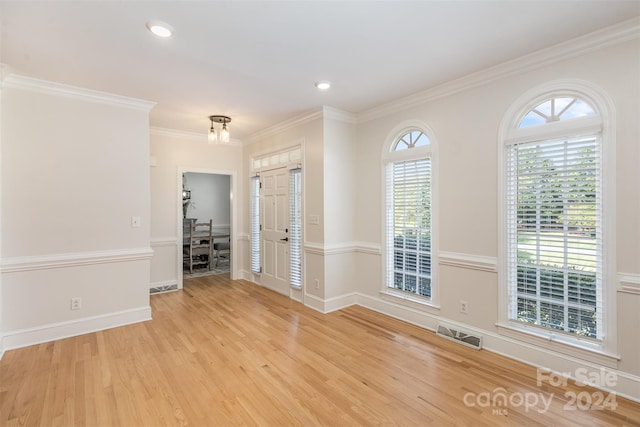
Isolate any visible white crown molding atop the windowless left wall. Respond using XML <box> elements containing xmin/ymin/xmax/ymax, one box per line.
<box><xmin>2</xmin><ymin>74</ymin><xmax>156</xmax><ymax>113</ymax></box>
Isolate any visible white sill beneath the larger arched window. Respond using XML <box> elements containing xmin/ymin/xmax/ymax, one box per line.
<box><xmin>496</xmin><ymin>323</ymin><xmax>620</xmax><ymax>368</ymax></box>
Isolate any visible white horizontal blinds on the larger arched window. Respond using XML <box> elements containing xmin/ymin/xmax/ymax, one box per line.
<box><xmin>506</xmin><ymin>136</ymin><xmax>603</xmax><ymax>339</ymax></box>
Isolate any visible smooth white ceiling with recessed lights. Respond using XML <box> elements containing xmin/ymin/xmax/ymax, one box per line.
<box><xmin>0</xmin><ymin>0</ymin><xmax>640</xmax><ymax>139</ymax></box>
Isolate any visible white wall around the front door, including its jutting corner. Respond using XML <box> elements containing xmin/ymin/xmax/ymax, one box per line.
<box><xmin>244</xmin><ymin>107</ymin><xmax>359</xmax><ymax>312</ymax></box>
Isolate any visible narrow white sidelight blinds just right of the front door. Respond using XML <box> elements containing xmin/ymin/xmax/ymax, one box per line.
<box><xmin>289</xmin><ymin>168</ymin><xmax>302</xmax><ymax>287</ymax></box>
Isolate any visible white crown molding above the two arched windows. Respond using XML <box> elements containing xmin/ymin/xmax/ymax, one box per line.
<box><xmin>357</xmin><ymin>18</ymin><xmax>640</xmax><ymax>123</ymax></box>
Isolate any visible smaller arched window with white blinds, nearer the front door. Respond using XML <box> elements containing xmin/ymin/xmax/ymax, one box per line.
<box><xmin>384</xmin><ymin>127</ymin><xmax>434</xmax><ymax>302</ymax></box>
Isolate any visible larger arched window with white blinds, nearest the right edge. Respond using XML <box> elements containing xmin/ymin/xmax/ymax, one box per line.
<box><xmin>501</xmin><ymin>82</ymin><xmax>612</xmax><ymax>356</ymax></box>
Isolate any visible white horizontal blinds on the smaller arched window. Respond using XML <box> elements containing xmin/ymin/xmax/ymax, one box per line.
<box><xmin>386</xmin><ymin>158</ymin><xmax>431</xmax><ymax>298</ymax></box>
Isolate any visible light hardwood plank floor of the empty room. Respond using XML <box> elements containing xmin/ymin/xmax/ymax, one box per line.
<box><xmin>0</xmin><ymin>276</ymin><xmax>640</xmax><ymax>426</ymax></box>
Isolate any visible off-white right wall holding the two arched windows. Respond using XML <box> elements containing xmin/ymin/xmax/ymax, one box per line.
<box><xmin>352</xmin><ymin>38</ymin><xmax>640</xmax><ymax>399</ymax></box>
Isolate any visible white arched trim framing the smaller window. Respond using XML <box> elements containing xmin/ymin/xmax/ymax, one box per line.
<box><xmin>380</xmin><ymin>120</ymin><xmax>440</xmax><ymax>311</ymax></box>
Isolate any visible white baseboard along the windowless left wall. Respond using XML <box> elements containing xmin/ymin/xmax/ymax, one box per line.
<box><xmin>0</xmin><ymin>306</ymin><xmax>151</xmax><ymax>354</ymax></box>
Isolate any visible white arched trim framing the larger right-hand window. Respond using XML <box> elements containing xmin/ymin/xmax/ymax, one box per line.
<box><xmin>496</xmin><ymin>79</ymin><xmax>618</xmax><ymax>364</ymax></box>
